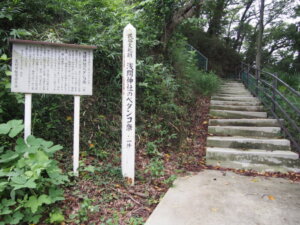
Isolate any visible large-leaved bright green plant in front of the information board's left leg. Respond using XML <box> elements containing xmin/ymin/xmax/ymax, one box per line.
<box><xmin>0</xmin><ymin>120</ymin><xmax>68</xmax><ymax>225</ymax></box>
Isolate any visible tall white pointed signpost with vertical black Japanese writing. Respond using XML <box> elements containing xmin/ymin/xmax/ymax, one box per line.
<box><xmin>122</xmin><ymin>24</ymin><xmax>136</xmax><ymax>185</ymax></box>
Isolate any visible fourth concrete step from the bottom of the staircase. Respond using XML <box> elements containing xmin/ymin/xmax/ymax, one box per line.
<box><xmin>209</xmin><ymin>119</ymin><xmax>279</xmax><ymax>127</ymax></box>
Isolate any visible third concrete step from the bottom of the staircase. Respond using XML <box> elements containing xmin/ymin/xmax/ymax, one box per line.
<box><xmin>208</xmin><ymin>126</ymin><xmax>281</xmax><ymax>137</ymax></box>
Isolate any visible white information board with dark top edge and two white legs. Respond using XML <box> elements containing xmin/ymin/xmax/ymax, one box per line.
<box><xmin>10</xmin><ymin>39</ymin><xmax>96</xmax><ymax>174</ymax></box>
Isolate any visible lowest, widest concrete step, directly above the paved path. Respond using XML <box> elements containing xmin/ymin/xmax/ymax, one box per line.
<box><xmin>206</xmin><ymin>147</ymin><xmax>300</xmax><ymax>172</ymax></box>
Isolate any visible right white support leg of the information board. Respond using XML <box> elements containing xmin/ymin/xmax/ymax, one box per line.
<box><xmin>73</xmin><ymin>96</ymin><xmax>80</xmax><ymax>175</ymax></box>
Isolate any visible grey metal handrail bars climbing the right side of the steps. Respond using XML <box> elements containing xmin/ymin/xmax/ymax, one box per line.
<box><xmin>240</xmin><ymin>63</ymin><xmax>300</xmax><ymax>153</ymax></box>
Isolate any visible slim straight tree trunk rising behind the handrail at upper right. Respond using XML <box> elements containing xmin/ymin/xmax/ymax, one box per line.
<box><xmin>255</xmin><ymin>0</ymin><xmax>265</xmax><ymax>78</ymax></box>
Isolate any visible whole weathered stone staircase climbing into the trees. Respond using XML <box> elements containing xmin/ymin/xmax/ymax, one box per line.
<box><xmin>206</xmin><ymin>81</ymin><xmax>300</xmax><ymax>172</ymax></box>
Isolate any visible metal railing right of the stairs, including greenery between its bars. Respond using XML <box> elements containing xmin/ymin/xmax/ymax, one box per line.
<box><xmin>239</xmin><ymin>63</ymin><xmax>300</xmax><ymax>154</ymax></box>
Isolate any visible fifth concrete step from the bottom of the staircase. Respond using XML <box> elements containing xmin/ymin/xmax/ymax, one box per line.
<box><xmin>209</xmin><ymin>109</ymin><xmax>267</xmax><ymax>119</ymax></box>
